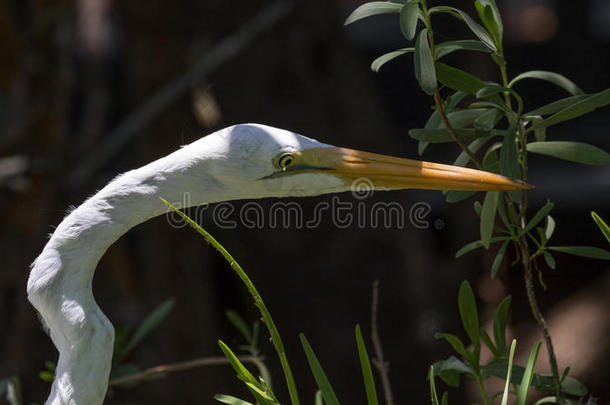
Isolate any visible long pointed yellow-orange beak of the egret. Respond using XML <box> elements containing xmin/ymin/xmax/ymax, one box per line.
<box><xmin>304</xmin><ymin>147</ymin><xmax>532</xmax><ymax>191</ymax></box>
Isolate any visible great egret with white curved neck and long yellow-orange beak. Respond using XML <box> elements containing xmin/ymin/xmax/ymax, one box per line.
<box><xmin>27</xmin><ymin>124</ymin><xmax>529</xmax><ymax>405</ymax></box>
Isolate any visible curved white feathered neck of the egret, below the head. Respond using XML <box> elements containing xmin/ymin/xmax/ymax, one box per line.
<box><xmin>27</xmin><ymin>155</ymin><xmax>211</xmax><ymax>405</ymax></box>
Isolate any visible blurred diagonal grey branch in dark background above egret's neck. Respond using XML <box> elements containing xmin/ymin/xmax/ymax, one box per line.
<box><xmin>68</xmin><ymin>0</ymin><xmax>293</xmax><ymax>188</ymax></box>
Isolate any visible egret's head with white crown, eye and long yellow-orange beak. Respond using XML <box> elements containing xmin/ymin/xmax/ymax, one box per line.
<box><xmin>180</xmin><ymin>124</ymin><xmax>531</xmax><ymax>198</ymax></box>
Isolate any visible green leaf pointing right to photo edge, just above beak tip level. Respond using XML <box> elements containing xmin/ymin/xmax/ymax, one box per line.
<box><xmin>527</xmin><ymin>141</ymin><xmax>610</xmax><ymax>165</ymax></box>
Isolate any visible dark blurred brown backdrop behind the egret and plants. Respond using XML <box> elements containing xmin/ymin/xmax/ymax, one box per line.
<box><xmin>0</xmin><ymin>0</ymin><xmax>610</xmax><ymax>404</ymax></box>
